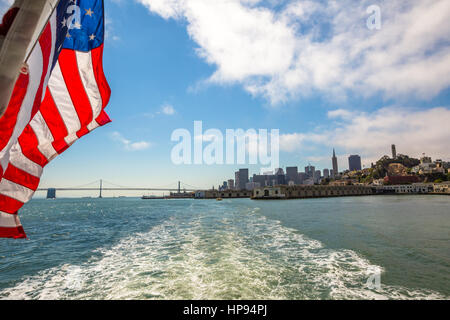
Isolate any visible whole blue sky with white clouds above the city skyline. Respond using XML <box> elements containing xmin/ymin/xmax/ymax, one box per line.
<box><xmin>2</xmin><ymin>0</ymin><xmax>450</xmax><ymax>196</ymax></box>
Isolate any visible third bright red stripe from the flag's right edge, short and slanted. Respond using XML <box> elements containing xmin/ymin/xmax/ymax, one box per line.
<box><xmin>39</xmin><ymin>88</ymin><xmax>69</xmax><ymax>153</ymax></box>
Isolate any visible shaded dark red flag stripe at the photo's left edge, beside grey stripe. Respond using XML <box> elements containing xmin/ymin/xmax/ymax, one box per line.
<box><xmin>0</xmin><ymin>73</ymin><xmax>30</xmax><ymax>150</ymax></box>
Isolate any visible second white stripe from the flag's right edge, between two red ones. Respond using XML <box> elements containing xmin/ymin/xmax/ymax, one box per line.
<box><xmin>48</xmin><ymin>62</ymin><xmax>81</xmax><ymax>134</ymax></box>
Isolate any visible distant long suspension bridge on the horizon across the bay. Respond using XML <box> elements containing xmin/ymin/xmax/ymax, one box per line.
<box><xmin>36</xmin><ymin>179</ymin><xmax>202</xmax><ymax>198</ymax></box>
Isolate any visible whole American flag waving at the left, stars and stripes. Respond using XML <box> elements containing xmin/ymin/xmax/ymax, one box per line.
<box><xmin>0</xmin><ymin>0</ymin><xmax>111</xmax><ymax>238</ymax></box>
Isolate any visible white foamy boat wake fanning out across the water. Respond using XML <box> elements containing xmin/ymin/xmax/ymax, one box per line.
<box><xmin>0</xmin><ymin>206</ymin><xmax>448</xmax><ymax>299</ymax></box>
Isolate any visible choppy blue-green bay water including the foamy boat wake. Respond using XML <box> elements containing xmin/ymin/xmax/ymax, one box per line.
<box><xmin>0</xmin><ymin>196</ymin><xmax>450</xmax><ymax>299</ymax></box>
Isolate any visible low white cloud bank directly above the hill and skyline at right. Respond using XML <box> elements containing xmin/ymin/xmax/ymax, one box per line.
<box><xmin>280</xmin><ymin>107</ymin><xmax>450</xmax><ymax>161</ymax></box>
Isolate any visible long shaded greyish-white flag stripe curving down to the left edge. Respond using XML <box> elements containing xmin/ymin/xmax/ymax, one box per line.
<box><xmin>0</xmin><ymin>44</ymin><xmax>43</xmax><ymax>168</ymax></box>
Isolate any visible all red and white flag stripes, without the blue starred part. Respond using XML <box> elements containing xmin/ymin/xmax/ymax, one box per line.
<box><xmin>0</xmin><ymin>1</ymin><xmax>111</xmax><ymax>238</ymax></box>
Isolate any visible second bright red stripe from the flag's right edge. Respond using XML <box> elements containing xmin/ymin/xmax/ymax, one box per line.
<box><xmin>58</xmin><ymin>49</ymin><xmax>93</xmax><ymax>137</ymax></box>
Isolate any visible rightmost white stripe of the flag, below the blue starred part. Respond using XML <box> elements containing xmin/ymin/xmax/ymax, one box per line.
<box><xmin>76</xmin><ymin>51</ymin><xmax>102</xmax><ymax>119</ymax></box>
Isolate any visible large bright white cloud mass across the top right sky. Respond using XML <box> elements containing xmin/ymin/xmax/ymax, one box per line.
<box><xmin>137</xmin><ymin>0</ymin><xmax>450</xmax><ymax>104</ymax></box>
